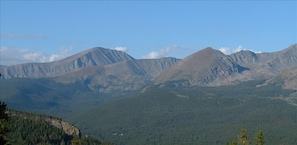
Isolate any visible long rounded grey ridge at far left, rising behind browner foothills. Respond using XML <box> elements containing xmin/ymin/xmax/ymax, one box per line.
<box><xmin>0</xmin><ymin>47</ymin><xmax>134</xmax><ymax>79</ymax></box>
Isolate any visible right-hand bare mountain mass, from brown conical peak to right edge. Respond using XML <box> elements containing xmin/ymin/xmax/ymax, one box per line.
<box><xmin>155</xmin><ymin>44</ymin><xmax>297</xmax><ymax>86</ymax></box>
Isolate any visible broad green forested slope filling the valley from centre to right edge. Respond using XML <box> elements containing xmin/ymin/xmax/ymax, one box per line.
<box><xmin>74</xmin><ymin>82</ymin><xmax>297</xmax><ymax>145</ymax></box>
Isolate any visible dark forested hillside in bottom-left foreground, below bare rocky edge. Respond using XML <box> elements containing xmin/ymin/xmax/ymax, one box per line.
<box><xmin>5</xmin><ymin>109</ymin><xmax>111</xmax><ymax>145</ymax></box>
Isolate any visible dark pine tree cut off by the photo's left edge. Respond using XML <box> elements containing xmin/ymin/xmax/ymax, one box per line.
<box><xmin>0</xmin><ymin>101</ymin><xmax>8</xmax><ymax>145</ymax></box>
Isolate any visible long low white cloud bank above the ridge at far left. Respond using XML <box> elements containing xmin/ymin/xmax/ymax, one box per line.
<box><xmin>0</xmin><ymin>46</ymin><xmax>74</xmax><ymax>65</ymax></box>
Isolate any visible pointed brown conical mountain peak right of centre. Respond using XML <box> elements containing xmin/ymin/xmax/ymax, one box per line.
<box><xmin>155</xmin><ymin>47</ymin><xmax>241</xmax><ymax>86</ymax></box>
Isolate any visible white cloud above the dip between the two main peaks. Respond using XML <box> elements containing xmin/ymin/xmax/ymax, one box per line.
<box><xmin>142</xmin><ymin>45</ymin><xmax>193</xmax><ymax>59</ymax></box>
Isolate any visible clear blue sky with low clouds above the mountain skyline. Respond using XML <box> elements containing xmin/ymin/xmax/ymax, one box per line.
<box><xmin>0</xmin><ymin>0</ymin><xmax>297</xmax><ymax>65</ymax></box>
